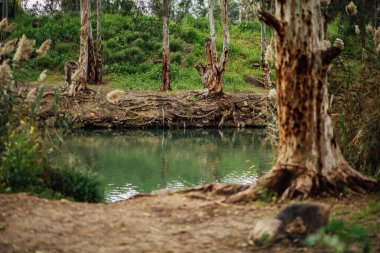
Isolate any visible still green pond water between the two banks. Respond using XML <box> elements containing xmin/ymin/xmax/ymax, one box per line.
<box><xmin>61</xmin><ymin>129</ymin><xmax>272</xmax><ymax>202</ymax></box>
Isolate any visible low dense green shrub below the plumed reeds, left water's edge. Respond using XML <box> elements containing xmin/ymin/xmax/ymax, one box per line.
<box><xmin>0</xmin><ymin>121</ymin><xmax>103</xmax><ymax>202</ymax></box>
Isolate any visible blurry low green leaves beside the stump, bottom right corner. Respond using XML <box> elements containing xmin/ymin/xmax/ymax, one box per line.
<box><xmin>304</xmin><ymin>220</ymin><xmax>371</xmax><ymax>253</ymax></box>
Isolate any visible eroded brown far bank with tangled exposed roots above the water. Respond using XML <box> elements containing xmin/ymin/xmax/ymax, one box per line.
<box><xmin>20</xmin><ymin>85</ymin><xmax>268</xmax><ymax>128</ymax></box>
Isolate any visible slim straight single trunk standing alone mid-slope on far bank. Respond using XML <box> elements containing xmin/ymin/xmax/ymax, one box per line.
<box><xmin>161</xmin><ymin>0</ymin><xmax>171</xmax><ymax>91</ymax></box>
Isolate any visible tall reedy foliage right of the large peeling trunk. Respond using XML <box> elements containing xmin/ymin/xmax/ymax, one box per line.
<box><xmin>329</xmin><ymin>7</ymin><xmax>380</xmax><ymax>177</ymax></box>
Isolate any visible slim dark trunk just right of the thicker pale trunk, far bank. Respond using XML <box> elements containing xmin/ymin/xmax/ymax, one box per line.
<box><xmin>95</xmin><ymin>0</ymin><xmax>103</xmax><ymax>84</ymax></box>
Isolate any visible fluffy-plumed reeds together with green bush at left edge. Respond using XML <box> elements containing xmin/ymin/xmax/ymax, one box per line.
<box><xmin>0</xmin><ymin>22</ymin><xmax>102</xmax><ymax>202</ymax></box>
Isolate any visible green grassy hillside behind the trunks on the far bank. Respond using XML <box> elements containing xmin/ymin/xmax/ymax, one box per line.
<box><xmin>9</xmin><ymin>14</ymin><xmax>270</xmax><ymax>92</ymax></box>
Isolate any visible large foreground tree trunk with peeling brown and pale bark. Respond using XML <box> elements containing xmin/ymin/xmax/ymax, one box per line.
<box><xmin>259</xmin><ymin>0</ymin><xmax>376</xmax><ymax>202</ymax></box>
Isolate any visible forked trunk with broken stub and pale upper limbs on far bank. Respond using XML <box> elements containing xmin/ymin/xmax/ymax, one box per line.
<box><xmin>195</xmin><ymin>0</ymin><xmax>230</xmax><ymax>94</ymax></box>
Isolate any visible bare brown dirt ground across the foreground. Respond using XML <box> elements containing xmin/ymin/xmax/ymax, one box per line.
<box><xmin>0</xmin><ymin>192</ymin><xmax>380</xmax><ymax>253</ymax></box>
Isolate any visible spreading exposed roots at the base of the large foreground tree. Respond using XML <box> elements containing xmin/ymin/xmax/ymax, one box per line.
<box><xmin>186</xmin><ymin>161</ymin><xmax>380</xmax><ymax>203</ymax></box>
